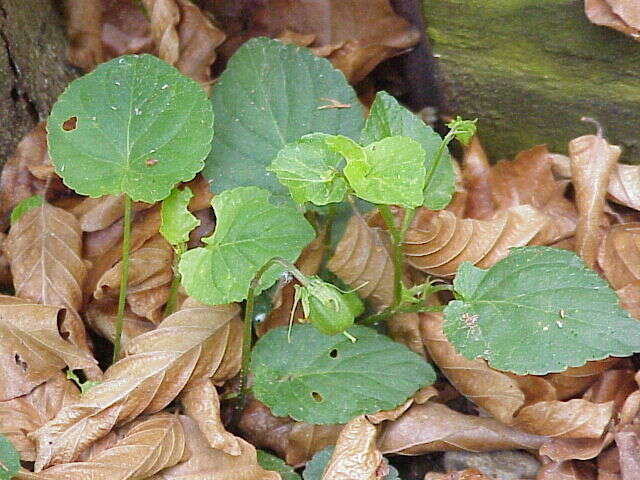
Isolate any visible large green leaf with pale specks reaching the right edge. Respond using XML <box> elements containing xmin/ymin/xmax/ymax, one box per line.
<box><xmin>444</xmin><ymin>247</ymin><xmax>640</xmax><ymax>375</ymax></box>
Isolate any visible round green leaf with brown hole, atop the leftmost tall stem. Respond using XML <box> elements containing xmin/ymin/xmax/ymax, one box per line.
<box><xmin>47</xmin><ymin>55</ymin><xmax>213</xmax><ymax>203</ymax></box>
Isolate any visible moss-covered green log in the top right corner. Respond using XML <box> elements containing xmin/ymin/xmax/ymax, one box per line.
<box><xmin>423</xmin><ymin>0</ymin><xmax>640</xmax><ymax>163</ymax></box>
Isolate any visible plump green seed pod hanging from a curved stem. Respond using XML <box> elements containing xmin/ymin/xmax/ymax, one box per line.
<box><xmin>300</xmin><ymin>278</ymin><xmax>362</xmax><ymax>335</ymax></box>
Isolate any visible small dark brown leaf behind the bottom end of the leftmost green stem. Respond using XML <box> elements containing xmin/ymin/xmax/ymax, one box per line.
<box><xmin>84</xmin><ymin>300</ymin><xmax>155</xmax><ymax>348</ymax></box>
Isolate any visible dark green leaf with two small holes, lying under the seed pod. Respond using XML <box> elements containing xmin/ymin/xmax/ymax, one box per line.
<box><xmin>251</xmin><ymin>324</ymin><xmax>435</xmax><ymax>424</ymax></box>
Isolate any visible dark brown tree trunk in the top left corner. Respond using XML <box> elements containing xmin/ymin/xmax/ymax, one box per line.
<box><xmin>0</xmin><ymin>0</ymin><xmax>77</xmax><ymax>163</ymax></box>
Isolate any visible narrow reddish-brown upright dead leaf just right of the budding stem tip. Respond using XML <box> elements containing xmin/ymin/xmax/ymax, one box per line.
<box><xmin>462</xmin><ymin>135</ymin><xmax>495</xmax><ymax>220</ymax></box>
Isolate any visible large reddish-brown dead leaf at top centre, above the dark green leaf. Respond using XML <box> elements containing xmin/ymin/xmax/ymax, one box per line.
<box><xmin>211</xmin><ymin>0</ymin><xmax>420</xmax><ymax>83</ymax></box>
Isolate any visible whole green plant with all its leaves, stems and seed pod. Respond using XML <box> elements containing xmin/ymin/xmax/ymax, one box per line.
<box><xmin>37</xmin><ymin>38</ymin><xmax>640</xmax><ymax>464</ymax></box>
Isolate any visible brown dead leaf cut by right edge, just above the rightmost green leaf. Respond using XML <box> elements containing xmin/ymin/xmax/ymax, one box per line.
<box><xmin>598</xmin><ymin>222</ymin><xmax>640</xmax><ymax>290</ymax></box>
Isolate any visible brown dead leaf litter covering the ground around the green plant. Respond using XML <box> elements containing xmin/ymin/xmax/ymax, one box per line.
<box><xmin>0</xmin><ymin>0</ymin><xmax>640</xmax><ymax>480</ymax></box>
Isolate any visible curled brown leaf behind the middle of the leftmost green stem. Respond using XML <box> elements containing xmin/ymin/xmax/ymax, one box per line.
<box><xmin>93</xmin><ymin>234</ymin><xmax>173</xmax><ymax>323</ymax></box>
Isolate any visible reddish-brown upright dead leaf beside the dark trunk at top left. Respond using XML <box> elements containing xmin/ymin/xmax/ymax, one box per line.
<box><xmin>64</xmin><ymin>0</ymin><xmax>105</xmax><ymax>72</ymax></box>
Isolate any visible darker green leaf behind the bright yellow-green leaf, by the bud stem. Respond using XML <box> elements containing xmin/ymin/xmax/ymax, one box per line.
<box><xmin>361</xmin><ymin>92</ymin><xmax>455</xmax><ymax>210</ymax></box>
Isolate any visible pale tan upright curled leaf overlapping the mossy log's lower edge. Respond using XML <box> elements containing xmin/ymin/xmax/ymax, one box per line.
<box><xmin>569</xmin><ymin>127</ymin><xmax>621</xmax><ymax>268</ymax></box>
